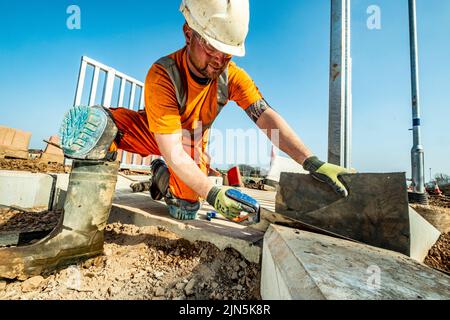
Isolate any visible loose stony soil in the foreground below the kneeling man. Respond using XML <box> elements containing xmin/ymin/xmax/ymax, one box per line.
<box><xmin>0</xmin><ymin>224</ymin><xmax>260</xmax><ymax>300</ymax></box>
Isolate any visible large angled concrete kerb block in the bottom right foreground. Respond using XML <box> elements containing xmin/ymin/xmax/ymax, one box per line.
<box><xmin>261</xmin><ymin>225</ymin><xmax>450</xmax><ymax>300</ymax></box>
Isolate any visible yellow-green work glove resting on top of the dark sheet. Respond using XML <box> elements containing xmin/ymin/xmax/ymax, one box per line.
<box><xmin>303</xmin><ymin>156</ymin><xmax>356</xmax><ymax>197</ymax></box>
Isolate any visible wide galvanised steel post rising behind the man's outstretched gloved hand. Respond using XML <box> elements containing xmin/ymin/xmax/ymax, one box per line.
<box><xmin>328</xmin><ymin>0</ymin><xmax>352</xmax><ymax>168</ymax></box>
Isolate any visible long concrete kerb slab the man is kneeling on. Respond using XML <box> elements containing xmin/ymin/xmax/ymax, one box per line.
<box><xmin>109</xmin><ymin>189</ymin><xmax>275</xmax><ymax>263</ymax></box>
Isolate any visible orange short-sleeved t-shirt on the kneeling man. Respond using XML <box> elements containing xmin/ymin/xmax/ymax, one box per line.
<box><xmin>145</xmin><ymin>47</ymin><xmax>262</xmax><ymax>134</ymax></box>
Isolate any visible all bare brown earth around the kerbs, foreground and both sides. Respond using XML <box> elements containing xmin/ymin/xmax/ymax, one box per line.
<box><xmin>0</xmin><ymin>159</ymin><xmax>450</xmax><ymax>300</ymax></box>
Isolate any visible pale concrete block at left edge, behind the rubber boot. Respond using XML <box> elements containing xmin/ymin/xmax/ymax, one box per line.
<box><xmin>0</xmin><ymin>170</ymin><xmax>54</xmax><ymax>210</ymax></box>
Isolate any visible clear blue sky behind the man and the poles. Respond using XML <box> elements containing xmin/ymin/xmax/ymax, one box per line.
<box><xmin>0</xmin><ymin>0</ymin><xmax>450</xmax><ymax>179</ymax></box>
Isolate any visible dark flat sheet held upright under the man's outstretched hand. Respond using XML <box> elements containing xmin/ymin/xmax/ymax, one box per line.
<box><xmin>276</xmin><ymin>173</ymin><xmax>410</xmax><ymax>255</ymax></box>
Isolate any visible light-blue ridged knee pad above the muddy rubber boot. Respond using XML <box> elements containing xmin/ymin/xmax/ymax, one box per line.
<box><xmin>60</xmin><ymin>106</ymin><xmax>118</xmax><ymax>160</ymax></box>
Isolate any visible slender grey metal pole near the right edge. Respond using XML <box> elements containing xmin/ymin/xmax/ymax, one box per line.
<box><xmin>408</xmin><ymin>0</ymin><xmax>425</xmax><ymax>193</ymax></box>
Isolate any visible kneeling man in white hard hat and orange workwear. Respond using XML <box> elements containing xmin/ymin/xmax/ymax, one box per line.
<box><xmin>61</xmin><ymin>0</ymin><xmax>356</xmax><ymax>220</ymax></box>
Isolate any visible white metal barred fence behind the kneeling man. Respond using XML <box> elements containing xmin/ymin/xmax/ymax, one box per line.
<box><xmin>74</xmin><ymin>56</ymin><xmax>158</xmax><ymax>169</ymax></box>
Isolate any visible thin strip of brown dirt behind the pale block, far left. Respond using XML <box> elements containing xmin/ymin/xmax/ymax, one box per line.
<box><xmin>0</xmin><ymin>159</ymin><xmax>70</xmax><ymax>173</ymax></box>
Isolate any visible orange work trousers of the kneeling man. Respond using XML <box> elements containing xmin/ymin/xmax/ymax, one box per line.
<box><xmin>109</xmin><ymin>108</ymin><xmax>210</xmax><ymax>202</ymax></box>
